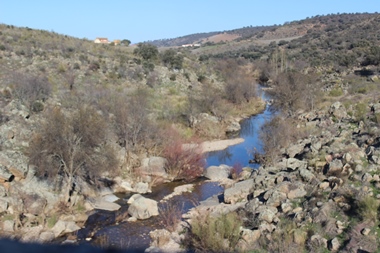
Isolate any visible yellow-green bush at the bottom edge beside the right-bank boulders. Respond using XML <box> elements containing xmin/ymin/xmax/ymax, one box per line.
<box><xmin>185</xmin><ymin>212</ymin><xmax>242</xmax><ymax>252</ymax></box>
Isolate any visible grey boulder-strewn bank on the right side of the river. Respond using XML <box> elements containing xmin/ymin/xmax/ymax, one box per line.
<box><xmin>150</xmin><ymin>102</ymin><xmax>380</xmax><ymax>252</ymax></box>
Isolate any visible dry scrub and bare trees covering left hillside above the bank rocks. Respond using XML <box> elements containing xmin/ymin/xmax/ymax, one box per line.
<box><xmin>0</xmin><ymin>22</ymin><xmax>259</xmax><ymax>207</ymax></box>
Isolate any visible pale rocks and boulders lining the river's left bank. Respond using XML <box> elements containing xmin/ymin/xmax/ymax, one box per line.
<box><xmin>0</xmin><ymin>95</ymin><xmax>262</xmax><ymax>243</ymax></box>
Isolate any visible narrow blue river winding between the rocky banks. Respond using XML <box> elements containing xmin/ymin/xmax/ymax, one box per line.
<box><xmin>77</xmin><ymin>88</ymin><xmax>273</xmax><ymax>250</ymax></box>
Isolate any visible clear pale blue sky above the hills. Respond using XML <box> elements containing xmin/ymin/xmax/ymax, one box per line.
<box><xmin>0</xmin><ymin>0</ymin><xmax>380</xmax><ymax>43</ymax></box>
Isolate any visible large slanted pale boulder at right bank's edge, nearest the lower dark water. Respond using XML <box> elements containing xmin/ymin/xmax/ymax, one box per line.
<box><xmin>224</xmin><ymin>179</ymin><xmax>255</xmax><ymax>204</ymax></box>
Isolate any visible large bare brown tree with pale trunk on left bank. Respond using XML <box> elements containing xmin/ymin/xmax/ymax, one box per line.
<box><xmin>28</xmin><ymin>106</ymin><xmax>117</xmax><ymax>202</ymax></box>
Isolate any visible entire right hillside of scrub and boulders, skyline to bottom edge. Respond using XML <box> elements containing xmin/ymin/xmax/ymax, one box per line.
<box><xmin>147</xmin><ymin>14</ymin><xmax>380</xmax><ymax>252</ymax></box>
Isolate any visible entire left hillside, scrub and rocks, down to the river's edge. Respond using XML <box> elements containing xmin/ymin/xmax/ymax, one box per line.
<box><xmin>0</xmin><ymin>21</ymin><xmax>264</xmax><ymax>247</ymax></box>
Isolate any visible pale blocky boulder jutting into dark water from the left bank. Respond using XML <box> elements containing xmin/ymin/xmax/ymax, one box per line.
<box><xmin>128</xmin><ymin>194</ymin><xmax>158</xmax><ymax>220</ymax></box>
